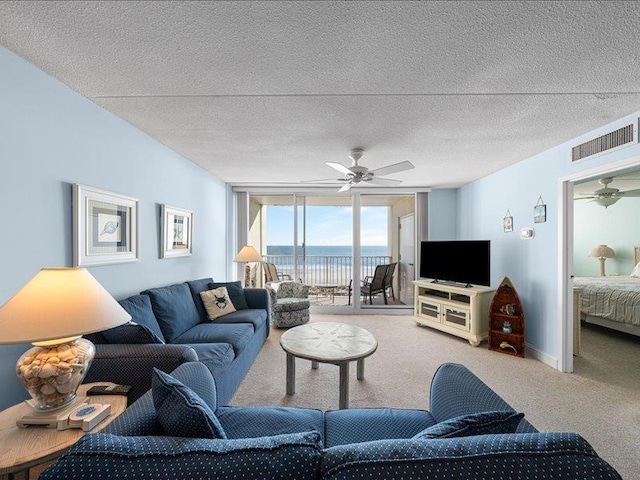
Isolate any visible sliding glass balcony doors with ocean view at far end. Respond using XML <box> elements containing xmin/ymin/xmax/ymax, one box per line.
<box><xmin>248</xmin><ymin>194</ymin><xmax>414</xmax><ymax>312</ymax></box>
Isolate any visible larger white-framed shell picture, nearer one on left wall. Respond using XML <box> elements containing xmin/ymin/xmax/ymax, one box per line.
<box><xmin>72</xmin><ymin>183</ymin><xmax>138</xmax><ymax>267</ymax></box>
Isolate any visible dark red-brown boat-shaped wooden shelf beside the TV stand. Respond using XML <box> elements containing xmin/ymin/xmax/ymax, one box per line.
<box><xmin>489</xmin><ymin>277</ymin><xmax>524</xmax><ymax>358</ymax></box>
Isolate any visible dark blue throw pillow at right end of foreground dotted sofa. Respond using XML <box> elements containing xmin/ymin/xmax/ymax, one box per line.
<box><xmin>413</xmin><ymin>410</ymin><xmax>524</xmax><ymax>439</ymax></box>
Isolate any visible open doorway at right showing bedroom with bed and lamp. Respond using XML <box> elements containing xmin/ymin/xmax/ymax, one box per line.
<box><xmin>573</xmin><ymin>170</ymin><xmax>640</xmax><ymax>348</ymax></box>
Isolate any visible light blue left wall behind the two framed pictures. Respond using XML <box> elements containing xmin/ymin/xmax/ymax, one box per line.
<box><xmin>0</xmin><ymin>47</ymin><xmax>228</xmax><ymax>409</ymax></box>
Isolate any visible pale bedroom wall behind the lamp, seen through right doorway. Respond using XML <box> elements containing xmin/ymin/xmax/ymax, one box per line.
<box><xmin>573</xmin><ymin>197</ymin><xmax>640</xmax><ymax>277</ymax></box>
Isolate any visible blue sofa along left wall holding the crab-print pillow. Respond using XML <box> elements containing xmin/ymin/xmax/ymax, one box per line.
<box><xmin>84</xmin><ymin>278</ymin><xmax>270</xmax><ymax>405</ymax></box>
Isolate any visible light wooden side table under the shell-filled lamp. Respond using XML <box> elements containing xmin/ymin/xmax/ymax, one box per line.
<box><xmin>0</xmin><ymin>382</ymin><xmax>127</xmax><ymax>480</ymax></box>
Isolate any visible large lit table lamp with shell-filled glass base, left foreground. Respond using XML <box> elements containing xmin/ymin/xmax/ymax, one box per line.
<box><xmin>0</xmin><ymin>268</ymin><xmax>131</xmax><ymax>412</ymax></box>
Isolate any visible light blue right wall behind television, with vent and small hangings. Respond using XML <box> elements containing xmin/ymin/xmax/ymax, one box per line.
<box><xmin>458</xmin><ymin>112</ymin><xmax>640</xmax><ymax>363</ymax></box>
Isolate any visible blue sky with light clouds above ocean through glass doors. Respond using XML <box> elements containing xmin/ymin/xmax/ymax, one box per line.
<box><xmin>267</xmin><ymin>206</ymin><xmax>389</xmax><ymax>246</ymax></box>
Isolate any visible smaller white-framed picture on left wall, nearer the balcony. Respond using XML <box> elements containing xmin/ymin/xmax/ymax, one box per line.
<box><xmin>160</xmin><ymin>205</ymin><xmax>193</xmax><ymax>258</ymax></box>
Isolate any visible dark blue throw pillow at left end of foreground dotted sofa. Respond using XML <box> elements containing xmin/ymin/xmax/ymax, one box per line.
<box><xmin>151</xmin><ymin>368</ymin><xmax>227</xmax><ymax>438</ymax></box>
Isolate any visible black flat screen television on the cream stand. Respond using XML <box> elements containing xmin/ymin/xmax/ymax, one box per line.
<box><xmin>420</xmin><ymin>240</ymin><xmax>491</xmax><ymax>286</ymax></box>
